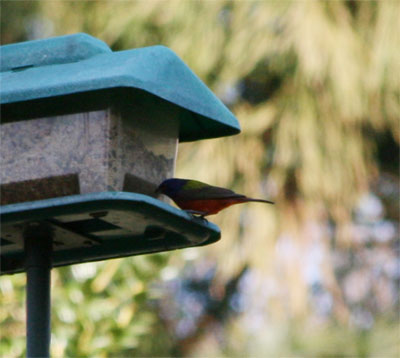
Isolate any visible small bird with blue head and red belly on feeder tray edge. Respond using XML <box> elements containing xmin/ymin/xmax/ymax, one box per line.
<box><xmin>156</xmin><ymin>178</ymin><xmax>273</xmax><ymax>217</ymax></box>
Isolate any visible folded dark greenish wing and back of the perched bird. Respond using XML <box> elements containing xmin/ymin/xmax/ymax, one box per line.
<box><xmin>177</xmin><ymin>182</ymin><xmax>245</xmax><ymax>200</ymax></box>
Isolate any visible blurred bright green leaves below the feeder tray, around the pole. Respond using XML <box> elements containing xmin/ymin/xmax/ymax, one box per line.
<box><xmin>0</xmin><ymin>254</ymin><xmax>169</xmax><ymax>357</ymax></box>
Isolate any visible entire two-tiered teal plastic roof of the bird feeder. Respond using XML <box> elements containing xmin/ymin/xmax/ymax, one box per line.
<box><xmin>0</xmin><ymin>34</ymin><xmax>240</xmax><ymax>141</ymax></box>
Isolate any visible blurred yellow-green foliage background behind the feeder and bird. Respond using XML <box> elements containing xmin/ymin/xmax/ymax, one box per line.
<box><xmin>0</xmin><ymin>0</ymin><xmax>400</xmax><ymax>358</ymax></box>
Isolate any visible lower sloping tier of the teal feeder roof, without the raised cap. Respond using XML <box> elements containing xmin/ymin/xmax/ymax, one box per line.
<box><xmin>0</xmin><ymin>46</ymin><xmax>240</xmax><ymax>141</ymax></box>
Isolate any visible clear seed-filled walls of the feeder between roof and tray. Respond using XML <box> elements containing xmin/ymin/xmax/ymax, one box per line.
<box><xmin>0</xmin><ymin>97</ymin><xmax>180</xmax><ymax>205</ymax></box>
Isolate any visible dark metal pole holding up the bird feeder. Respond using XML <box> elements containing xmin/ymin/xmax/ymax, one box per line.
<box><xmin>24</xmin><ymin>223</ymin><xmax>52</xmax><ymax>358</ymax></box>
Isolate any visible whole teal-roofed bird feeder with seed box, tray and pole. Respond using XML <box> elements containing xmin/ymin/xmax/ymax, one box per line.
<box><xmin>0</xmin><ymin>34</ymin><xmax>240</xmax><ymax>357</ymax></box>
